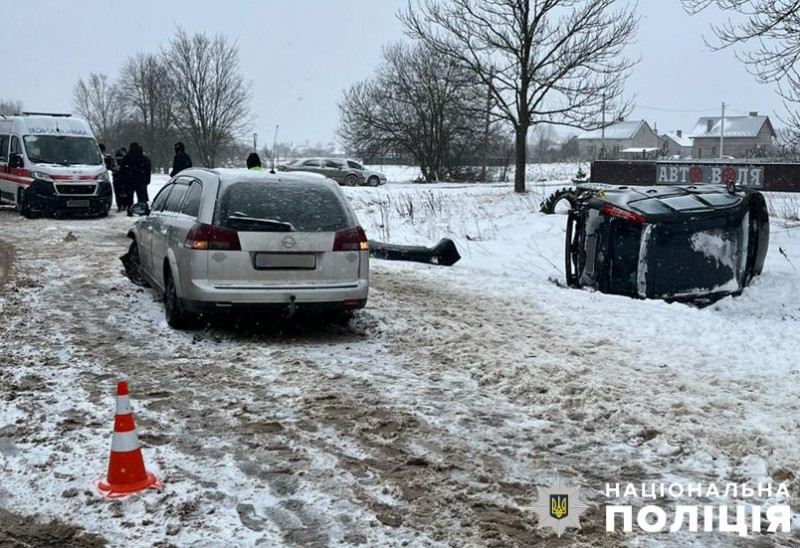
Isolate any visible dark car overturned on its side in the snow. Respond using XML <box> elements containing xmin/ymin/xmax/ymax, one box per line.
<box><xmin>565</xmin><ymin>184</ymin><xmax>769</xmax><ymax>304</ymax></box>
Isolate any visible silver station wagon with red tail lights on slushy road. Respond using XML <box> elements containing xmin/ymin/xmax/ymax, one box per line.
<box><xmin>123</xmin><ymin>169</ymin><xmax>369</xmax><ymax>329</ymax></box>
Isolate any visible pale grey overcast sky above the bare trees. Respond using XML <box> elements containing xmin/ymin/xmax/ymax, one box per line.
<box><xmin>0</xmin><ymin>0</ymin><xmax>782</xmax><ymax>147</ymax></box>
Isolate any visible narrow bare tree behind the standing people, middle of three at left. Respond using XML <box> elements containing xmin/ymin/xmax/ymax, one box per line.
<box><xmin>120</xmin><ymin>53</ymin><xmax>176</xmax><ymax>167</ymax></box>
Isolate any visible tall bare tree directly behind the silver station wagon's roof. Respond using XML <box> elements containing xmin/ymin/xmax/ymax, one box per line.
<box><xmin>162</xmin><ymin>29</ymin><xmax>251</xmax><ymax>167</ymax></box>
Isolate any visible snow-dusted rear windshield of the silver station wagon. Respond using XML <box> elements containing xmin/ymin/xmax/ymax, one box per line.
<box><xmin>214</xmin><ymin>181</ymin><xmax>353</xmax><ymax>232</ymax></box>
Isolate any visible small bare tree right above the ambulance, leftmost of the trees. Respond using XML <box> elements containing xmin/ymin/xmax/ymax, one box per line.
<box><xmin>72</xmin><ymin>73</ymin><xmax>125</xmax><ymax>142</ymax></box>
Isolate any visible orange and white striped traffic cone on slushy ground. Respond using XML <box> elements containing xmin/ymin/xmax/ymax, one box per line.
<box><xmin>95</xmin><ymin>381</ymin><xmax>163</xmax><ymax>499</ymax></box>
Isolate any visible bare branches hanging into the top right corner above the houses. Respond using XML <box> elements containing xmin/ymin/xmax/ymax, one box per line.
<box><xmin>681</xmin><ymin>0</ymin><xmax>800</xmax><ymax>143</ymax></box>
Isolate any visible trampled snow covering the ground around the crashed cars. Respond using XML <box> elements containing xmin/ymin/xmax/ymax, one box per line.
<box><xmin>0</xmin><ymin>165</ymin><xmax>800</xmax><ymax>546</ymax></box>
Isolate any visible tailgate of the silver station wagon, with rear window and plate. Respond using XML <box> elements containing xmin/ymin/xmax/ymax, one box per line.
<box><xmin>208</xmin><ymin>181</ymin><xmax>363</xmax><ymax>288</ymax></box>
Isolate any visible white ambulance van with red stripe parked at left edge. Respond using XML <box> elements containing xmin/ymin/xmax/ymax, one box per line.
<box><xmin>0</xmin><ymin>112</ymin><xmax>112</xmax><ymax>218</ymax></box>
